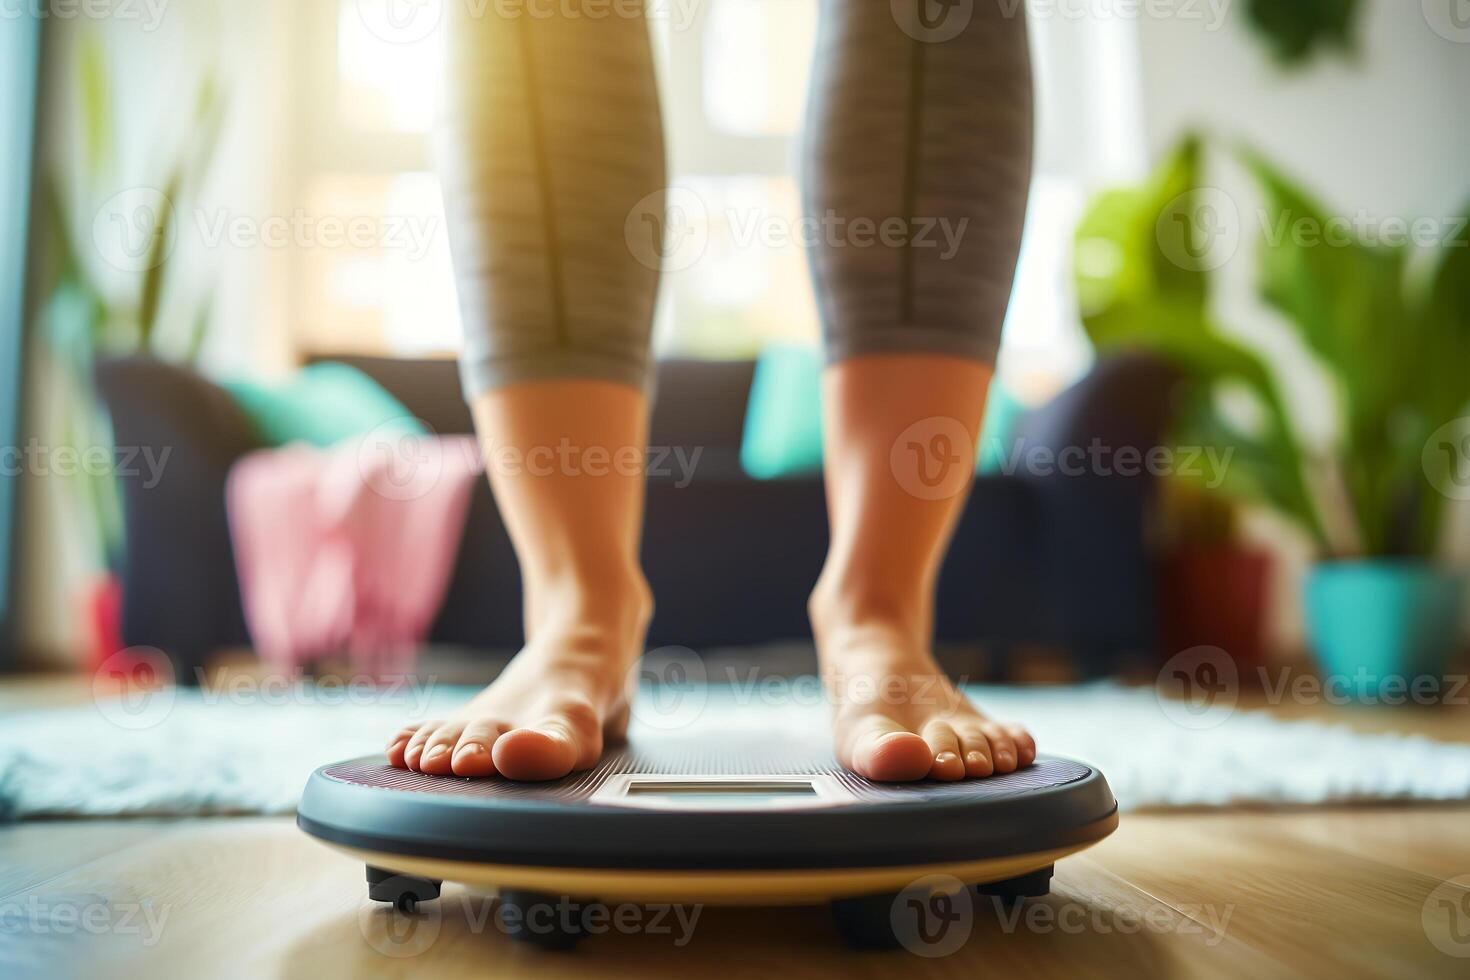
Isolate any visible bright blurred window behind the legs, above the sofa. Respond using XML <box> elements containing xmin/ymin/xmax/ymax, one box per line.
<box><xmin>280</xmin><ymin>0</ymin><xmax>1142</xmax><ymax>395</ymax></box>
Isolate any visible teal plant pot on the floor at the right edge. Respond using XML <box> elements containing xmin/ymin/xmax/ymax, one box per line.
<box><xmin>1307</xmin><ymin>561</ymin><xmax>1466</xmax><ymax>702</ymax></box>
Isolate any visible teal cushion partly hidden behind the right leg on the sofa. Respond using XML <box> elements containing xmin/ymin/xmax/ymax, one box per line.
<box><xmin>739</xmin><ymin>345</ymin><xmax>1026</xmax><ymax>480</ymax></box>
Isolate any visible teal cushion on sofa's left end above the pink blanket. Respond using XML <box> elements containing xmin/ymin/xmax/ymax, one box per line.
<box><xmin>225</xmin><ymin>361</ymin><xmax>428</xmax><ymax>447</ymax></box>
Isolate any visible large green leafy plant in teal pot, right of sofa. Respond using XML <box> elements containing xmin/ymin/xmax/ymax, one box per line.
<box><xmin>1075</xmin><ymin>135</ymin><xmax>1470</xmax><ymax>698</ymax></box>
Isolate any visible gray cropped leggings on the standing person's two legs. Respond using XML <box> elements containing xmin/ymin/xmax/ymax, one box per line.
<box><xmin>441</xmin><ymin>0</ymin><xmax>1032</xmax><ymax>397</ymax></box>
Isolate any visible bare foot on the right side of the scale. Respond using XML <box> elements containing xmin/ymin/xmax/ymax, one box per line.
<box><xmin>813</xmin><ymin>601</ymin><xmax>1036</xmax><ymax>783</ymax></box>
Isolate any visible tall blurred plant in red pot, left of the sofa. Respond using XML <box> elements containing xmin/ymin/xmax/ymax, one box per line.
<box><xmin>40</xmin><ymin>32</ymin><xmax>225</xmax><ymax>667</ymax></box>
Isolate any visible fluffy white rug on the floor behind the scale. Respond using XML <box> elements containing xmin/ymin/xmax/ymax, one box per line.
<box><xmin>0</xmin><ymin>682</ymin><xmax>1470</xmax><ymax>821</ymax></box>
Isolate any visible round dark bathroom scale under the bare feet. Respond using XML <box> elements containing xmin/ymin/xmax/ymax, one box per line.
<box><xmin>297</xmin><ymin>714</ymin><xmax>1117</xmax><ymax>948</ymax></box>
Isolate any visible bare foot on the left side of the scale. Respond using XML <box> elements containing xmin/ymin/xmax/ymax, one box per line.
<box><xmin>387</xmin><ymin>581</ymin><xmax>648</xmax><ymax>780</ymax></box>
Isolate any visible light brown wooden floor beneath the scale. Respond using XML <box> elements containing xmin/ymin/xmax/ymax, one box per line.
<box><xmin>0</xmin><ymin>687</ymin><xmax>1470</xmax><ymax>980</ymax></box>
